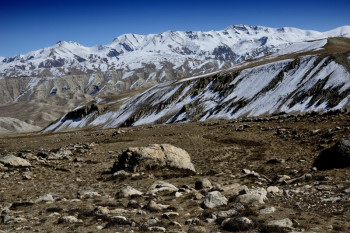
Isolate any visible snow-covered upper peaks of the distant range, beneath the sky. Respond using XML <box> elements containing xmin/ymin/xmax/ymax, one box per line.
<box><xmin>0</xmin><ymin>25</ymin><xmax>350</xmax><ymax>79</ymax></box>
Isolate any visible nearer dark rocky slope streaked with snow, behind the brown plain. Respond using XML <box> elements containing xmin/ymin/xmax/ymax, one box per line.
<box><xmin>45</xmin><ymin>38</ymin><xmax>350</xmax><ymax>132</ymax></box>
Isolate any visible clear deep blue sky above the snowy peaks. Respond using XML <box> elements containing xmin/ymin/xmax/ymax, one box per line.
<box><xmin>0</xmin><ymin>0</ymin><xmax>350</xmax><ymax>57</ymax></box>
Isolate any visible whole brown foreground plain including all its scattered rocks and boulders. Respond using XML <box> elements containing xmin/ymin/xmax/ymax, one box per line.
<box><xmin>0</xmin><ymin>111</ymin><xmax>350</xmax><ymax>232</ymax></box>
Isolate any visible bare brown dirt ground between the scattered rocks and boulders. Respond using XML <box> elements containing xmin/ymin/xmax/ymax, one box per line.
<box><xmin>0</xmin><ymin>114</ymin><xmax>350</xmax><ymax>232</ymax></box>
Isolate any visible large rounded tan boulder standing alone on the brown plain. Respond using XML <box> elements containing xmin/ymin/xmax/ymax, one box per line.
<box><xmin>112</xmin><ymin>144</ymin><xmax>195</xmax><ymax>173</ymax></box>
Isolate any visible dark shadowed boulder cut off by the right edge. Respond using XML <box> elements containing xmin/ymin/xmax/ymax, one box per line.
<box><xmin>313</xmin><ymin>140</ymin><xmax>350</xmax><ymax>170</ymax></box>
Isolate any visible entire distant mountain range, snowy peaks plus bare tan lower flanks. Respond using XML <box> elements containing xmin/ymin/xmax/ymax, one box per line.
<box><xmin>0</xmin><ymin>25</ymin><xmax>350</xmax><ymax>131</ymax></box>
